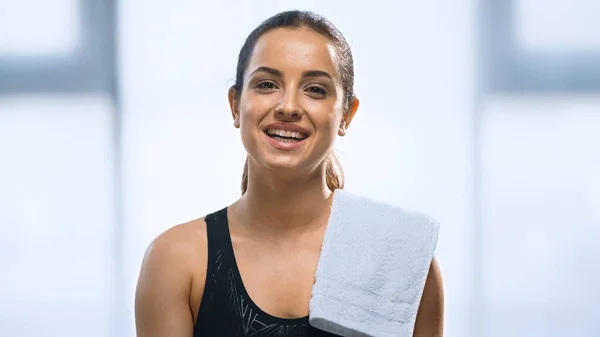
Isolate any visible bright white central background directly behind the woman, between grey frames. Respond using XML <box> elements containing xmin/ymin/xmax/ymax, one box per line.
<box><xmin>119</xmin><ymin>0</ymin><xmax>474</xmax><ymax>336</ymax></box>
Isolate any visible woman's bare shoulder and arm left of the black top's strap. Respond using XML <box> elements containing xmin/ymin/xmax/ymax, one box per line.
<box><xmin>135</xmin><ymin>218</ymin><xmax>208</xmax><ymax>337</ymax></box>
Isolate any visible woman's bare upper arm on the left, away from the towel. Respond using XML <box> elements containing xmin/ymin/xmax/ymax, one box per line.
<box><xmin>135</xmin><ymin>229</ymin><xmax>199</xmax><ymax>337</ymax></box>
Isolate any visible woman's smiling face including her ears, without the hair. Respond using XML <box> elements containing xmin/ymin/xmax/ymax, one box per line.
<box><xmin>229</xmin><ymin>28</ymin><xmax>358</xmax><ymax>176</ymax></box>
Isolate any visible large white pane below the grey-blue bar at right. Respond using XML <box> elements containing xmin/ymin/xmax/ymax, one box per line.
<box><xmin>481</xmin><ymin>95</ymin><xmax>600</xmax><ymax>337</ymax></box>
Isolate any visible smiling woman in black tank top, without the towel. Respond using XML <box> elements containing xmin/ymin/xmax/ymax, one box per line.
<box><xmin>135</xmin><ymin>11</ymin><xmax>443</xmax><ymax>337</ymax></box>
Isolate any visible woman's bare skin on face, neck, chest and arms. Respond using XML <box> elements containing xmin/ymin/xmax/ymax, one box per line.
<box><xmin>135</xmin><ymin>29</ymin><xmax>444</xmax><ymax>337</ymax></box>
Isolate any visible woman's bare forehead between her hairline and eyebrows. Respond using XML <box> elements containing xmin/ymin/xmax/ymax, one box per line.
<box><xmin>248</xmin><ymin>28</ymin><xmax>337</xmax><ymax>78</ymax></box>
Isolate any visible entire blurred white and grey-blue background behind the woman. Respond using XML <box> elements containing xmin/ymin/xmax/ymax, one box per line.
<box><xmin>0</xmin><ymin>0</ymin><xmax>600</xmax><ymax>337</ymax></box>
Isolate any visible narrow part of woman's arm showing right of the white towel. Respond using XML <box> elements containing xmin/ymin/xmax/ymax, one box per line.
<box><xmin>413</xmin><ymin>258</ymin><xmax>444</xmax><ymax>337</ymax></box>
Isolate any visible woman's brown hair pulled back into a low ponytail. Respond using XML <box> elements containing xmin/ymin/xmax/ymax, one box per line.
<box><xmin>233</xmin><ymin>11</ymin><xmax>354</xmax><ymax>194</ymax></box>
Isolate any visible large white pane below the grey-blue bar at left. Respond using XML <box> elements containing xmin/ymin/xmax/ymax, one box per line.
<box><xmin>0</xmin><ymin>95</ymin><xmax>116</xmax><ymax>337</ymax></box>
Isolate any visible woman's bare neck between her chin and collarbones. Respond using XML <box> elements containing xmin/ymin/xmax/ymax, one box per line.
<box><xmin>238</xmin><ymin>159</ymin><xmax>333</xmax><ymax>231</ymax></box>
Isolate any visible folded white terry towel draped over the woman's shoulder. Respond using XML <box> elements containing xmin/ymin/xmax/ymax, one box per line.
<box><xmin>309</xmin><ymin>190</ymin><xmax>439</xmax><ymax>337</ymax></box>
